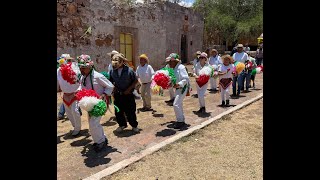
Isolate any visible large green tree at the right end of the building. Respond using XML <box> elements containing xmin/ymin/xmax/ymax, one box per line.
<box><xmin>193</xmin><ymin>0</ymin><xmax>263</xmax><ymax>49</ymax></box>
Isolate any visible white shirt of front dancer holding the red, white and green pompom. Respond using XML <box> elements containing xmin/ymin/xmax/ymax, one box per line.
<box><xmin>80</xmin><ymin>70</ymin><xmax>114</xmax><ymax>96</ymax></box>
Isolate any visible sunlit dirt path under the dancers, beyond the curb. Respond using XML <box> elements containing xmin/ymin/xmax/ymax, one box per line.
<box><xmin>57</xmin><ymin>65</ymin><xmax>263</xmax><ymax>180</ymax></box>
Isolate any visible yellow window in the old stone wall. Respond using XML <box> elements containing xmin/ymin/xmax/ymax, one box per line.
<box><xmin>120</xmin><ymin>33</ymin><xmax>134</xmax><ymax>67</ymax></box>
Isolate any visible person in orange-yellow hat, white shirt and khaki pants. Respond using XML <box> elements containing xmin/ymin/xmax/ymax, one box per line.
<box><xmin>136</xmin><ymin>54</ymin><xmax>154</xmax><ymax>111</ymax></box>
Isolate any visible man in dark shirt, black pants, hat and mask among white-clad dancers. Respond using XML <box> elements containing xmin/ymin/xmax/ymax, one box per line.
<box><xmin>110</xmin><ymin>53</ymin><xmax>139</xmax><ymax>132</ymax></box>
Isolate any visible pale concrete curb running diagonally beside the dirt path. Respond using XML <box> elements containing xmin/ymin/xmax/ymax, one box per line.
<box><xmin>84</xmin><ymin>93</ymin><xmax>263</xmax><ymax>180</ymax></box>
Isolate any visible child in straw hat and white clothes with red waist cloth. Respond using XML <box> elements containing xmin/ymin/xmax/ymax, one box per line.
<box><xmin>218</xmin><ymin>55</ymin><xmax>235</xmax><ymax>106</ymax></box>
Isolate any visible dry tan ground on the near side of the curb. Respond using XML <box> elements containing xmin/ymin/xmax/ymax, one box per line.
<box><xmin>103</xmin><ymin>99</ymin><xmax>263</xmax><ymax>180</ymax></box>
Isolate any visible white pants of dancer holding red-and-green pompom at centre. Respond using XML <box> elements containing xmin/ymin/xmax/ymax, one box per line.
<box><xmin>173</xmin><ymin>89</ymin><xmax>188</xmax><ymax>122</ymax></box>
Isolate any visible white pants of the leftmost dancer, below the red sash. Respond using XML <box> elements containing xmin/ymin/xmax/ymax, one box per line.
<box><xmin>64</xmin><ymin>101</ymin><xmax>81</xmax><ymax>131</ymax></box>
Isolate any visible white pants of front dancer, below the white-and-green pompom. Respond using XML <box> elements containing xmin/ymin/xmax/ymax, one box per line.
<box><xmin>88</xmin><ymin>115</ymin><xmax>106</xmax><ymax>144</ymax></box>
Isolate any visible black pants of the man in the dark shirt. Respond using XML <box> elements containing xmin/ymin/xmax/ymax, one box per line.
<box><xmin>114</xmin><ymin>94</ymin><xmax>138</xmax><ymax>127</ymax></box>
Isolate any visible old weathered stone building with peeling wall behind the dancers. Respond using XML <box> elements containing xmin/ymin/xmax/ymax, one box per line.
<box><xmin>57</xmin><ymin>0</ymin><xmax>204</xmax><ymax>71</ymax></box>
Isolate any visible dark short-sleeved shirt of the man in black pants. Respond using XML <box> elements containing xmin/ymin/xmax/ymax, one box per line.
<box><xmin>110</xmin><ymin>66</ymin><xmax>137</xmax><ymax>92</ymax></box>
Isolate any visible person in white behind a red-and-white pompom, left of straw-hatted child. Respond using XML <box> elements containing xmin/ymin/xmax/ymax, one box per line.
<box><xmin>193</xmin><ymin>52</ymin><xmax>210</xmax><ymax>113</ymax></box>
